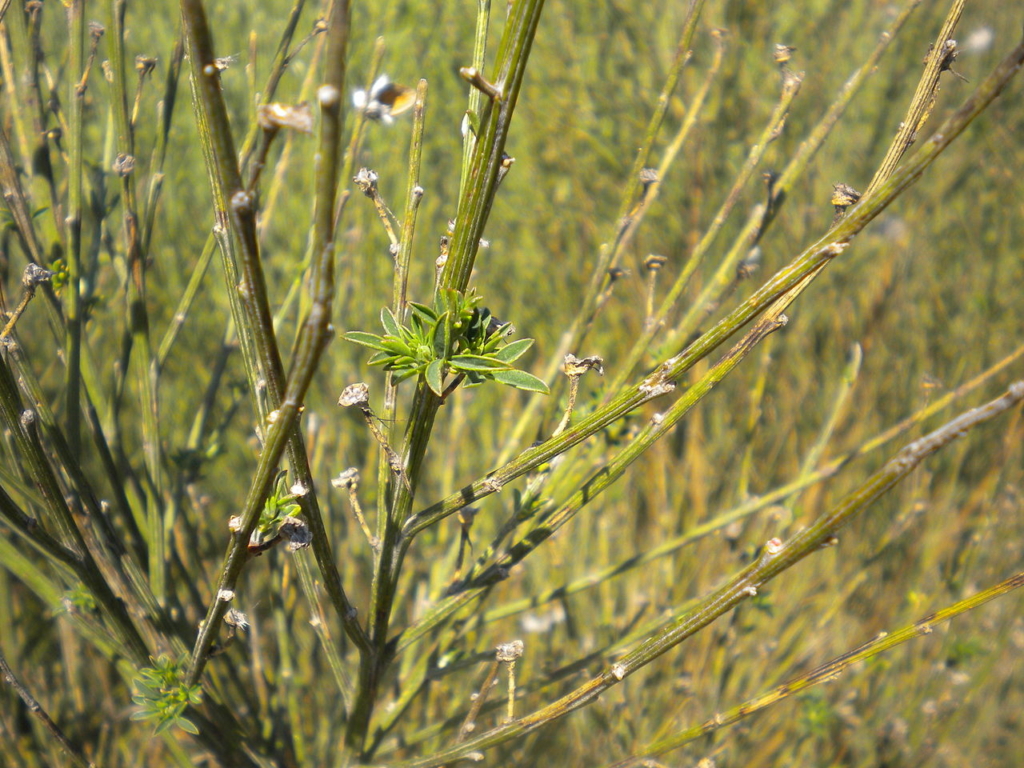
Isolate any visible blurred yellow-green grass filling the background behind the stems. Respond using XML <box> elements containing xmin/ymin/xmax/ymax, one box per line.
<box><xmin>0</xmin><ymin>0</ymin><xmax>1024</xmax><ymax>766</ymax></box>
